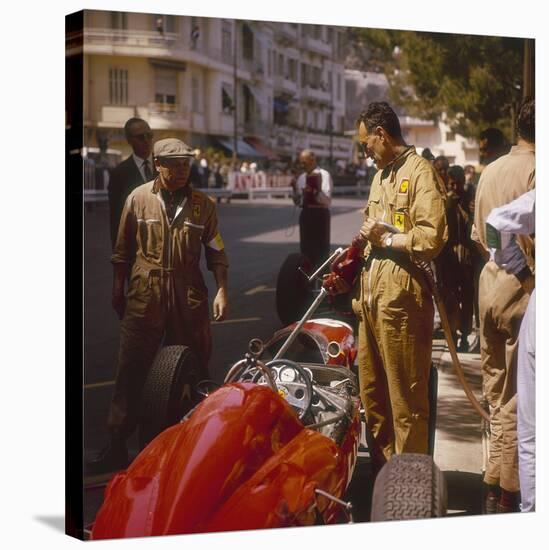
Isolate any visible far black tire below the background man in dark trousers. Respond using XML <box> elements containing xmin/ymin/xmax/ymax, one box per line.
<box><xmin>276</xmin><ymin>252</ymin><xmax>312</xmax><ymax>325</ymax></box>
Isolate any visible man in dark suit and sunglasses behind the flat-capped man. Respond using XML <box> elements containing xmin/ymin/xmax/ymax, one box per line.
<box><xmin>109</xmin><ymin>118</ymin><xmax>157</xmax><ymax>252</ymax></box>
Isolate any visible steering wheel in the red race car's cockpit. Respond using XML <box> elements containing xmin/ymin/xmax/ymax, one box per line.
<box><xmin>252</xmin><ymin>359</ymin><xmax>313</xmax><ymax>420</ymax></box>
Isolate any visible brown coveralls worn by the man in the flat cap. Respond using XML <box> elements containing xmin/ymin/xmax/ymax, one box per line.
<box><xmin>108</xmin><ymin>179</ymin><xmax>228</xmax><ymax>437</ymax></box>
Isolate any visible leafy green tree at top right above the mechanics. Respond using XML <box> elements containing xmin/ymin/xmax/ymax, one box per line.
<box><xmin>353</xmin><ymin>29</ymin><xmax>524</xmax><ymax>138</ymax></box>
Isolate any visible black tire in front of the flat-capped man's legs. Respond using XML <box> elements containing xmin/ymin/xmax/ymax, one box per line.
<box><xmin>138</xmin><ymin>346</ymin><xmax>207</xmax><ymax>449</ymax></box>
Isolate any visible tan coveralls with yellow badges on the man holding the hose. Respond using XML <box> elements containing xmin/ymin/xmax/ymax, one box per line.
<box><xmin>353</xmin><ymin>147</ymin><xmax>447</xmax><ymax>463</ymax></box>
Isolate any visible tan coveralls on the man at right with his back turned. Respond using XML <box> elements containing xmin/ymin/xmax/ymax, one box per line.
<box><xmin>471</xmin><ymin>144</ymin><xmax>535</xmax><ymax>492</ymax></box>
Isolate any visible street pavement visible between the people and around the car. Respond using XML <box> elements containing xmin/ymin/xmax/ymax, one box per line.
<box><xmin>80</xmin><ymin>198</ymin><xmax>482</xmax><ymax>524</ymax></box>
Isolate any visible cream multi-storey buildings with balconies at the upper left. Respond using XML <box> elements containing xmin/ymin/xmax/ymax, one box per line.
<box><xmin>84</xmin><ymin>10</ymin><xmax>352</xmax><ymax>161</ymax></box>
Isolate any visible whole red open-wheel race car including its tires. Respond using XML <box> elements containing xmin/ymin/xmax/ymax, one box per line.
<box><xmin>91</xmin><ymin>258</ymin><xmax>445</xmax><ymax>539</ymax></box>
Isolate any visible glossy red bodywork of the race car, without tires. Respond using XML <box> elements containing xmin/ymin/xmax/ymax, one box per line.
<box><xmin>92</xmin><ymin>319</ymin><xmax>360</xmax><ymax>539</ymax></box>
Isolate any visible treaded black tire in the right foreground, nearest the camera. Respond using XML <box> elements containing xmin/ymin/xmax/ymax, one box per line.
<box><xmin>371</xmin><ymin>453</ymin><xmax>446</xmax><ymax>521</ymax></box>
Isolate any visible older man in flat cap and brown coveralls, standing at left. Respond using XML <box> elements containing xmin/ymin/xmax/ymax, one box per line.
<box><xmin>88</xmin><ymin>138</ymin><xmax>228</xmax><ymax>472</ymax></box>
